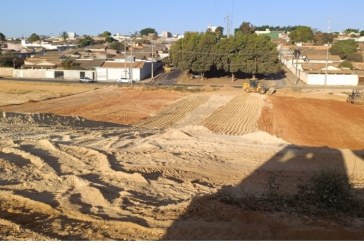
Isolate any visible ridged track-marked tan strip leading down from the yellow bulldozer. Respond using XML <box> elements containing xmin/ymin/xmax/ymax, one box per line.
<box><xmin>202</xmin><ymin>94</ymin><xmax>264</xmax><ymax>135</ymax></box>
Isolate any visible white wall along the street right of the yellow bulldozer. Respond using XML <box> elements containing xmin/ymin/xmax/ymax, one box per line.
<box><xmin>307</xmin><ymin>74</ymin><xmax>359</xmax><ymax>86</ymax></box>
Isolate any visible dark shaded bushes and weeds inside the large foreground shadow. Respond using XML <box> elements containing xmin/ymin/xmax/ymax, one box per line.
<box><xmin>216</xmin><ymin>170</ymin><xmax>364</xmax><ymax>217</ymax></box>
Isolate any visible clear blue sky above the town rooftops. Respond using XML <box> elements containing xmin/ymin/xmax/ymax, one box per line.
<box><xmin>0</xmin><ymin>0</ymin><xmax>364</xmax><ymax>37</ymax></box>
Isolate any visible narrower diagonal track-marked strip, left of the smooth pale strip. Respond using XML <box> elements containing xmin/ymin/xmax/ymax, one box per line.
<box><xmin>134</xmin><ymin>95</ymin><xmax>209</xmax><ymax>128</ymax></box>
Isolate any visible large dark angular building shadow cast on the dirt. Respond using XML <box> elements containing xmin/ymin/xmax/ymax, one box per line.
<box><xmin>162</xmin><ymin>146</ymin><xmax>364</xmax><ymax>240</ymax></box>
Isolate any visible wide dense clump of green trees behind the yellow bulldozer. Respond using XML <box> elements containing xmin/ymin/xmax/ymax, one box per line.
<box><xmin>170</xmin><ymin>31</ymin><xmax>281</xmax><ymax>78</ymax></box>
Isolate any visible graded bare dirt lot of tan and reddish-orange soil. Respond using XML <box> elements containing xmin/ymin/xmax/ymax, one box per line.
<box><xmin>0</xmin><ymin>80</ymin><xmax>364</xmax><ymax>240</ymax></box>
